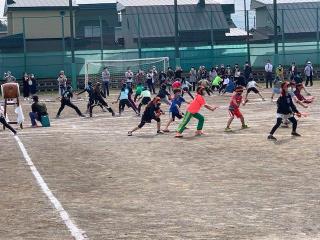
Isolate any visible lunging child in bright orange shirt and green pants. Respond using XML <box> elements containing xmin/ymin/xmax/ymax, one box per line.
<box><xmin>175</xmin><ymin>86</ymin><xmax>217</xmax><ymax>138</ymax></box>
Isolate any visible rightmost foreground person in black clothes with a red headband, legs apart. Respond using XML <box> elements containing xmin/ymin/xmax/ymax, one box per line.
<box><xmin>268</xmin><ymin>82</ymin><xmax>301</xmax><ymax>141</ymax></box>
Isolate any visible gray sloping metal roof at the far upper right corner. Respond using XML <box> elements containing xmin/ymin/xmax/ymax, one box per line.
<box><xmin>255</xmin><ymin>0</ymin><xmax>320</xmax><ymax>34</ymax></box>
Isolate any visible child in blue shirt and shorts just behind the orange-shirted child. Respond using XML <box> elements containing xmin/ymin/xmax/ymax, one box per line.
<box><xmin>163</xmin><ymin>89</ymin><xmax>190</xmax><ymax>132</ymax></box>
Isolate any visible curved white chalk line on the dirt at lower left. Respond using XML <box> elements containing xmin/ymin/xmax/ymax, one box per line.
<box><xmin>14</xmin><ymin>136</ymin><xmax>89</xmax><ymax>240</ymax></box>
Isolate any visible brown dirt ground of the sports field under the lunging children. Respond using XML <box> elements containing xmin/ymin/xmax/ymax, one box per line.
<box><xmin>0</xmin><ymin>84</ymin><xmax>320</xmax><ymax>240</ymax></box>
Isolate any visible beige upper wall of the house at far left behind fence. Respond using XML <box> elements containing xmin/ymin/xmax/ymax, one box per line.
<box><xmin>8</xmin><ymin>10</ymin><xmax>70</xmax><ymax>39</ymax></box>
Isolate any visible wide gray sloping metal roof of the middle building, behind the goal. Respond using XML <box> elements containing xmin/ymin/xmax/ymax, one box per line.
<box><xmin>123</xmin><ymin>4</ymin><xmax>229</xmax><ymax>38</ymax></box>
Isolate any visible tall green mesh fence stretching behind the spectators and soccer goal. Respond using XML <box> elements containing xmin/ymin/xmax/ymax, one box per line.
<box><xmin>0</xmin><ymin>7</ymin><xmax>320</xmax><ymax>78</ymax></box>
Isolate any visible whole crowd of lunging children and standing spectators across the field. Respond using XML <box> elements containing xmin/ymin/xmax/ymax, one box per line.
<box><xmin>0</xmin><ymin>61</ymin><xmax>314</xmax><ymax>140</ymax></box>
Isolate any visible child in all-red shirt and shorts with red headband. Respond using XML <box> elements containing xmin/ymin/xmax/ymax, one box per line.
<box><xmin>225</xmin><ymin>86</ymin><xmax>248</xmax><ymax>132</ymax></box>
